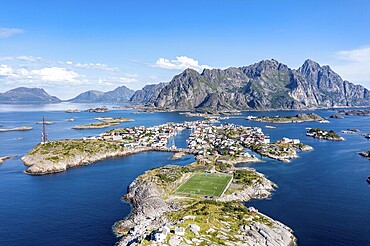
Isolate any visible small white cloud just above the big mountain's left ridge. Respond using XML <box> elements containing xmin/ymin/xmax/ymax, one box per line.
<box><xmin>153</xmin><ymin>56</ymin><xmax>211</xmax><ymax>72</ymax></box>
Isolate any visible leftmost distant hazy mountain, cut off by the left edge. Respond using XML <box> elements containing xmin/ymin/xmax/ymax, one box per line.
<box><xmin>0</xmin><ymin>87</ymin><xmax>61</xmax><ymax>103</ymax></box>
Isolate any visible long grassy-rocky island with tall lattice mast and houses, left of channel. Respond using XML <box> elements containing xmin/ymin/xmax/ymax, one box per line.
<box><xmin>22</xmin><ymin>123</ymin><xmax>189</xmax><ymax>175</ymax></box>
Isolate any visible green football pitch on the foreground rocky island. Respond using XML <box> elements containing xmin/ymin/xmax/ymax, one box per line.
<box><xmin>176</xmin><ymin>173</ymin><xmax>232</xmax><ymax>196</ymax></box>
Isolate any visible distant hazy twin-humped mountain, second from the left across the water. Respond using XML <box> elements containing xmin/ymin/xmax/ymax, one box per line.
<box><xmin>68</xmin><ymin>86</ymin><xmax>135</xmax><ymax>103</ymax></box>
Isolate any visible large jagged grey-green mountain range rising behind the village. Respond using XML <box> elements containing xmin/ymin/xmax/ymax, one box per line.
<box><xmin>138</xmin><ymin>59</ymin><xmax>370</xmax><ymax>111</ymax></box>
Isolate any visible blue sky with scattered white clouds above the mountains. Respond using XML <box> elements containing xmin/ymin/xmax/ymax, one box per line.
<box><xmin>0</xmin><ymin>0</ymin><xmax>370</xmax><ymax>99</ymax></box>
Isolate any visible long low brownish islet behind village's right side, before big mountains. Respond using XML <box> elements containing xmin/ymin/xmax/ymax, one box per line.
<box><xmin>247</xmin><ymin>113</ymin><xmax>324</xmax><ymax>123</ymax></box>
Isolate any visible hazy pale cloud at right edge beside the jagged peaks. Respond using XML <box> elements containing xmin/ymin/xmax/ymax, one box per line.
<box><xmin>331</xmin><ymin>46</ymin><xmax>370</xmax><ymax>88</ymax></box>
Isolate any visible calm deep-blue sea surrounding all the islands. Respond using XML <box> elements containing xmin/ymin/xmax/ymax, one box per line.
<box><xmin>0</xmin><ymin>103</ymin><xmax>370</xmax><ymax>245</ymax></box>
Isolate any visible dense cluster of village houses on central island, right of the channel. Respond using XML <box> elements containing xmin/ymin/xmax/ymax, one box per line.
<box><xmin>187</xmin><ymin>124</ymin><xmax>270</xmax><ymax>155</ymax></box>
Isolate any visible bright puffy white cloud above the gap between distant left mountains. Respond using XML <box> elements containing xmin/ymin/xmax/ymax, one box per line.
<box><xmin>31</xmin><ymin>67</ymin><xmax>79</xmax><ymax>82</ymax></box>
